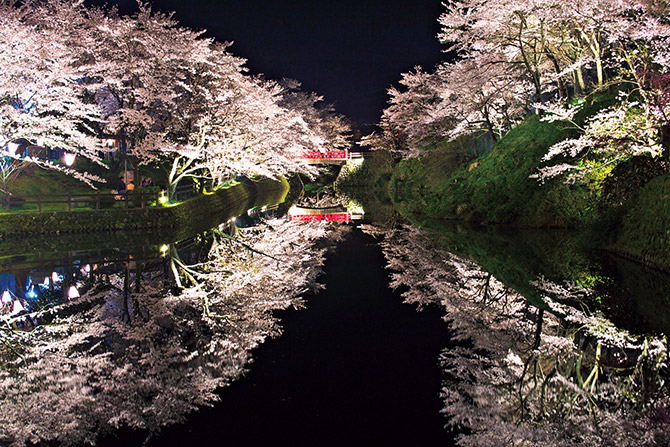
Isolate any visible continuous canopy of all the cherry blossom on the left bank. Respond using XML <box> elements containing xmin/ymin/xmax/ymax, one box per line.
<box><xmin>0</xmin><ymin>0</ymin><xmax>347</xmax><ymax>191</ymax></box>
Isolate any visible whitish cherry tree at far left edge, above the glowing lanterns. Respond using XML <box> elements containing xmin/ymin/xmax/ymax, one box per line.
<box><xmin>0</xmin><ymin>1</ymin><xmax>108</xmax><ymax>186</ymax></box>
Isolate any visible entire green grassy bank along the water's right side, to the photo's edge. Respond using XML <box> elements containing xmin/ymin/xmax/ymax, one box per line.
<box><xmin>343</xmin><ymin>95</ymin><xmax>670</xmax><ymax>271</ymax></box>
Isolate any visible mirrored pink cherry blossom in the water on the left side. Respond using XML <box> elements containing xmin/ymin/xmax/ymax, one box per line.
<box><xmin>0</xmin><ymin>219</ymin><xmax>346</xmax><ymax>445</ymax></box>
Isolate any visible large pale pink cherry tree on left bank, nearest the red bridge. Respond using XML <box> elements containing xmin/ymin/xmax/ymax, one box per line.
<box><xmin>83</xmin><ymin>5</ymin><xmax>346</xmax><ymax>192</ymax></box>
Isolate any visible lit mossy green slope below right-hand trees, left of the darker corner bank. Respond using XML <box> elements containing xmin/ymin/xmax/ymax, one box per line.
<box><xmin>389</xmin><ymin>96</ymin><xmax>624</xmax><ymax>228</ymax></box>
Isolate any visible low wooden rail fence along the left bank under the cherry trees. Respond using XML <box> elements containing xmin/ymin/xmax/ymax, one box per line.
<box><xmin>2</xmin><ymin>191</ymin><xmax>159</xmax><ymax>213</ymax></box>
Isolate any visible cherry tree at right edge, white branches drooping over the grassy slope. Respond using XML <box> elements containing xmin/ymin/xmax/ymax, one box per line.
<box><xmin>534</xmin><ymin>4</ymin><xmax>670</xmax><ymax>181</ymax></box>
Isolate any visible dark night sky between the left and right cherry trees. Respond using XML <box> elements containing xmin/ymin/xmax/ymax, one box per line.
<box><xmin>88</xmin><ymin>0</ymin><xmax>444</xmax><ymax>123</ymax></box>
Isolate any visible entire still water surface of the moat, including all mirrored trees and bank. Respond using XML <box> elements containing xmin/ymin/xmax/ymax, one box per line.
<box><xmin>0</xmin><ymin>185</ymin><xmax>670</xmax><ymax>446</ymax></box>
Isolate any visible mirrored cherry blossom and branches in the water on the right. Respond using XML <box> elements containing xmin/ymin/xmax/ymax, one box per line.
<box><xmin>367</xmin><ymin>227</ymin><xmax>670</xmax><ymax>446</ymax></box>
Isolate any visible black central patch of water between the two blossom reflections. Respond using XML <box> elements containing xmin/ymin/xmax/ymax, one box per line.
<box><xmin>98</xmin><ymin>229</ymin><xmax>462</xmax><ymax>446</ymax></box>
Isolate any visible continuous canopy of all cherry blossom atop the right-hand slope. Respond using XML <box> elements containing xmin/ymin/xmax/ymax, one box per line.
<box><xmin>379</xmin><ymin>0</ymin><xmax>670</xmax><ymax>181</ymax></box>
